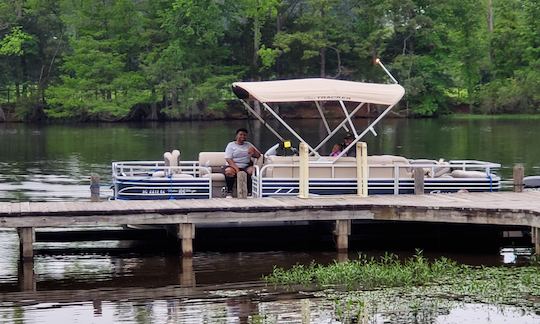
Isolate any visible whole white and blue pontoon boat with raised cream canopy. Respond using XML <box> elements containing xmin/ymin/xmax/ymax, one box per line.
<box><xmin>112</xmin><ymin>65</ymin><xmax>501</xmax><ymax>199</ymax></box>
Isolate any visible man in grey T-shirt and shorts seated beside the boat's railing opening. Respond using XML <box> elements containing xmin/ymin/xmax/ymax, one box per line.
<box><xmin>224</xmin><ymin>128</ymin><xmax>261</xmax><ymax>198</ymax></box>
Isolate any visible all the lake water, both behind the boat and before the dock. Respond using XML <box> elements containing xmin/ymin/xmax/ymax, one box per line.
<box><xmin>0</xmin><ymin>119</ymin><xmax>540</xmax><ymax>323</ymax></box>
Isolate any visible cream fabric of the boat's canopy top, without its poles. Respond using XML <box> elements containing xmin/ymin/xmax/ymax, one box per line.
<box><xmin>232</xmin><ymin>78</ymin><xmax>405</xmax><ymax>105</ymax></box>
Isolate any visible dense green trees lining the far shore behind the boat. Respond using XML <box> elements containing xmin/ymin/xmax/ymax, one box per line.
<box><xmin>0</xmin><ymin>0</ymin><xmax>540</xmax><ymax>120</ymax></box>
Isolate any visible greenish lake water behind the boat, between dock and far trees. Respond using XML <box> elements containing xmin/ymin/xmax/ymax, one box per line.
<box><xmin>0</xmin><ymin>119</ymin><xmax>540</xmax><ymax>201</ymax></box>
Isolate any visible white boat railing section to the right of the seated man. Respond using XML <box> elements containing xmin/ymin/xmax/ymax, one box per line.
<box><xmin>253</xmin><ymin>160</ymin><xmax>500</xmax><ymax>196</ymax></box>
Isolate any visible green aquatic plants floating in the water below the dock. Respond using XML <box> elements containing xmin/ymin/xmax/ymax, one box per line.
<box><xmin>264</xmin><ymin>251</ymin><xmax>540</xmax><ymax>322</ymax></box>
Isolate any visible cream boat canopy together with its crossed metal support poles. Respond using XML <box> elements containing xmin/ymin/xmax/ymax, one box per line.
<box><xmin>232</xmin><ymin>67</ymin><xmax>405</xmax><ymax>158</ymax></box>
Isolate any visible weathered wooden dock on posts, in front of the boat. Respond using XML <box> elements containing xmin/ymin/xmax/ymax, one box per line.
<box><xmin>0</xmin><ymin>191</ymin><xmax>540</xmax><ymax>258</ymax></box>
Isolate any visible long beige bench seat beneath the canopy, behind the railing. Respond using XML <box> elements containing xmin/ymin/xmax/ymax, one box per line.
<box><xmin>263</xmin><ymin>155</ymin><xmax>412</xmax><ymax>178</ymax></box>
